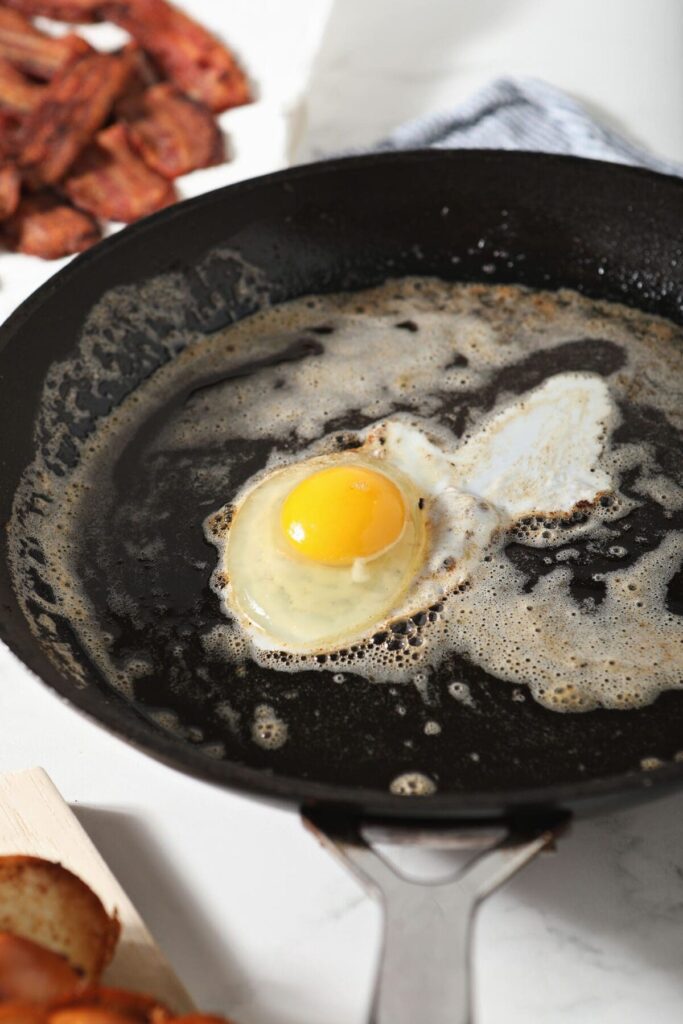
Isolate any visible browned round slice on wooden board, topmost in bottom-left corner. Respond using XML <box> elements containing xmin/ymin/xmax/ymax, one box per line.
<box><xmin>0</xmin><ymin>856</ymin><xmax>119</xmax><ymax>983</ymax></box>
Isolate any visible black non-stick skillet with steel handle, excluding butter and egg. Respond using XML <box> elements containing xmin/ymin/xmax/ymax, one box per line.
<box><xmin>0</xmin><ymin>152</ymin><xmax>683</xmax><ymax>1024</ymax></box>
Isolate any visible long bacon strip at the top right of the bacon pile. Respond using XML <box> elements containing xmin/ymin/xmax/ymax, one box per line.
<box><xmin>98</xmin><ymin>0</ymin><xmax>251</xmax><ymax>113</ymax></box>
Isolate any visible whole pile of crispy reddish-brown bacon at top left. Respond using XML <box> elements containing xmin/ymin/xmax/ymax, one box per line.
<box><xmin>0</xmin><ymin>0</ymin><xmax>237</xmax><ymax>262</ymax></box>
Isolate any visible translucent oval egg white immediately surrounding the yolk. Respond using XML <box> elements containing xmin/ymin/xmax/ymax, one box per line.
<box><xmin>207</xmin><ymin>452</ymin><xmax>427</xmax><ymax>650</ymax></box>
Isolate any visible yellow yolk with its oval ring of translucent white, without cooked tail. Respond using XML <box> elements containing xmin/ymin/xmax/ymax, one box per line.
<box><xmin>210</xmin><ymin>449</ymin><xmax>427</xmax><ymax>650</ymax></box>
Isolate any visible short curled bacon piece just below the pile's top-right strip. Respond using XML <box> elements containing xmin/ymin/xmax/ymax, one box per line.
<box><xmin>124</xmin><ymin>82</ymin><xmax>225</xmax><ymax>178</ymax></box>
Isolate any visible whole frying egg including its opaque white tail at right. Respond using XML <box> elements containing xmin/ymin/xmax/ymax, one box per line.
<box><xmin>205</xmin><ymin>373</ymin><xmax>614</xmax><ymax>660</ymax></box>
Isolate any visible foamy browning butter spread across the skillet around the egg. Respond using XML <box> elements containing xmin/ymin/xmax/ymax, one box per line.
<box><xmin>9</xmin><ymin>280</ymin><xmax>683</xmax><ymax>716</ymax></box>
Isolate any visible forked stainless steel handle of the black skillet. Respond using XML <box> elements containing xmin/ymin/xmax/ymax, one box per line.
<box><xmin>304</xmin><ymin>811</ymin><xmax>566</xmax><ymax>1024</ymax></box>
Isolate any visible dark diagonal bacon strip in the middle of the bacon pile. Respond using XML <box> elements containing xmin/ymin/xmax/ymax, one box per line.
<box><xmin>19</xmin><ymin>53</ymin><xmax>129</xmax><ymax>187</ymax></box>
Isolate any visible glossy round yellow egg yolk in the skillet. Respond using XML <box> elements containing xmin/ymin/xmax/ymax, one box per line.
<box><xmin>281</xmin><ymin>465</ymin><xmax>405</xmax><ymax>565</ymax></box>
